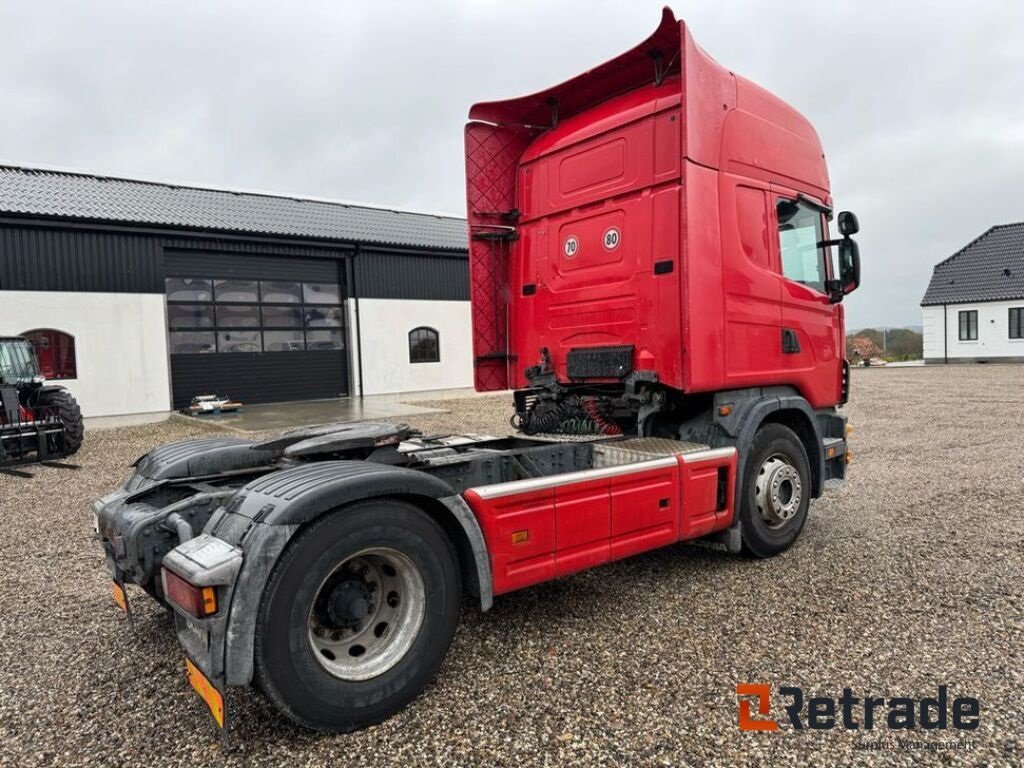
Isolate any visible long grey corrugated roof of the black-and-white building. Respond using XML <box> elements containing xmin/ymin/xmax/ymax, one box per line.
<box><xmin>0</xmin><ymin>165</ymin><xmax>468</xmax><ymax>251</ymax></box>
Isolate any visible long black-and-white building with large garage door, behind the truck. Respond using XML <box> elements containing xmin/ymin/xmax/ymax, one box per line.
<box><xmin>0</xmin><ymin>161</ymin><xmax>472</xmax><ymax>417</ymax></box>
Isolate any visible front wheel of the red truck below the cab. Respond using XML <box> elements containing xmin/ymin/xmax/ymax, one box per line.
<box><xmin>739</xmin><ymin>423</ymin><xmax>811</xmax><ymax>557</ymax></box>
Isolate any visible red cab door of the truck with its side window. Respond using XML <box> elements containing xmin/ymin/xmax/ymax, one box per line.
<box><xmin>772</xmin><ymin>185</ymin><xmax>843</xmax><ymax>408</ymax></box>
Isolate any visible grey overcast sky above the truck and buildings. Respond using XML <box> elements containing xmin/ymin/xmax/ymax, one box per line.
<box><xmin>0</xmin><ymin>0</ymin><xmax>1024</xmax><ymax>328</ymax></box>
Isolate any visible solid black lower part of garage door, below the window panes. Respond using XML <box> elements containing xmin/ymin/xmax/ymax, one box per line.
<box><xmin>171</xmin><ymin>349</ymin><xmax>348</xmax><ymax>409</ymax></box>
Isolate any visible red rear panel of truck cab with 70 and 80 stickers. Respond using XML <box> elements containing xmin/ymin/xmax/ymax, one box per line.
<box><xmin>509</xmin><ymin>84</ymin><xmax>681</xmax><ymax>387</ymax></box>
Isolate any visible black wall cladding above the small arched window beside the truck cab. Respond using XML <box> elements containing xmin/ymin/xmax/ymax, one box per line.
<box><xmin>353</xmin><ymin>250</ymin><xmax>469</xmax><ymax>301</ymax></box>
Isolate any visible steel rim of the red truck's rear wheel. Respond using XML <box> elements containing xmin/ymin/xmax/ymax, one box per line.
<box><xmin>307</xmin><ymin>547</ymin><xmax>426</xmax><ymax>681</ymax></box>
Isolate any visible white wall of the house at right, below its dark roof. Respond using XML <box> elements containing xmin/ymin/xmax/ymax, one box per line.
<box><xmin>922</xmin><ymin>299</ymin><xmax>1024</xmax><ymax>361</ymax></box>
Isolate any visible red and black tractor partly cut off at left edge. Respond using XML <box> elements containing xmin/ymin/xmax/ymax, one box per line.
<box><xmin>0</xmin><ymin>336</ymin><xmax>85</xmax><ymax>468</ymax></box>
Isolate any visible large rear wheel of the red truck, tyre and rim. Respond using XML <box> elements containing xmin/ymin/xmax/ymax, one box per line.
<box><xmin>255</xmin><ymin>500</ymin><xmax>462</xmax><ymax>731</ymax></box>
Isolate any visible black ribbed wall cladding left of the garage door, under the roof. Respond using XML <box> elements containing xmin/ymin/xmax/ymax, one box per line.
<box><xmin>0</xmin><ymin>226</ymin><xmax>164</xmax><ymax>293</ymax></box>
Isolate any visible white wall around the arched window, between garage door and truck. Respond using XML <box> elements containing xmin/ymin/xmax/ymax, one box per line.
<box><xmin>358</xmin><ymin>299</ymin><xmax>473</xmax><ymax>394</ymax></box>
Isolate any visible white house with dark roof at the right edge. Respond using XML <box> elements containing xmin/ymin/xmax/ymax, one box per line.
<box><xmin>921</xmin><ymin>222</ymin><xmax>1024</xmax><ymax>362</ymax></box>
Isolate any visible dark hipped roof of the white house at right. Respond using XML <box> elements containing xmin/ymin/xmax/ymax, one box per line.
<box><xmin>921</xmin><ymin>221</ymin><xmax>1024</xmax><ymax>306</ymax></box>
